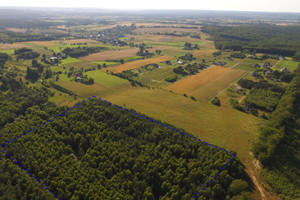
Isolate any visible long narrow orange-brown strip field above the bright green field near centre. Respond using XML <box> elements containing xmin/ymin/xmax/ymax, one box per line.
<box><xmin>101</xmin><ymin>56</ymin><xmax>174</xmax><ymax>73</ymax></box>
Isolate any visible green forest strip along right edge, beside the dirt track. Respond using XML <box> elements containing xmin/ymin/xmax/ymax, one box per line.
<box><xmin>253</xmin><ymin>65</ymin><xmax>300</xmax><ymax>200</ymax></box>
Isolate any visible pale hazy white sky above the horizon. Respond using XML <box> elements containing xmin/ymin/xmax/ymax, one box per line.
<box><xmin>0</xmin><ymin>0</ymin><xmax>300</xmax><ymax>12</ymax></box>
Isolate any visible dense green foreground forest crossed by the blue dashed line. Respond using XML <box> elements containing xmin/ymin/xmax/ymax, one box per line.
<box><xmin>0</xmin><ymin>88</ymin><xmax>249</xmax><ymax>200</ymax></box>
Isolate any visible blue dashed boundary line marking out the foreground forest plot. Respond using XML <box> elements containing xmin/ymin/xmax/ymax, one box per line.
<box><xmin>0</xmin><ymin>96</ymin><xmax>236</xmax><ymax>200</ymax></box>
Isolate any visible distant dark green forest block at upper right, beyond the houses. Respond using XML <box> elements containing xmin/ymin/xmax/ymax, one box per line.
<box><xmin>203</xmin><ymin>24</ymin><xmax>300</xmax><ymax>60</ymax></box>
